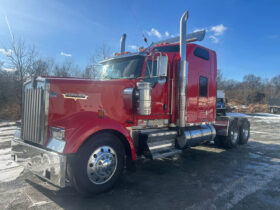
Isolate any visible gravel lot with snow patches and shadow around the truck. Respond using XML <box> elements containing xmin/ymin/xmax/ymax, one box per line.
<box><xmin>0</xmin><ymin>114</ymin><xmax>280</xmax><ymax>210</ymax></box>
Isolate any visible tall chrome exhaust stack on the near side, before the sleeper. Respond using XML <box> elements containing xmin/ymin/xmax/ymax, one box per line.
<box><xmin>177</xmin><ymin>10</ymin><xmax>189</xmax><ymax>128</ymax></box>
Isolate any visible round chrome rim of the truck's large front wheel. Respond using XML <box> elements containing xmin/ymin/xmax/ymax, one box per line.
<box><xmin>87</xmin><ymin>146</ymin><xmax>117</xmax><ymax>184</ymax></box>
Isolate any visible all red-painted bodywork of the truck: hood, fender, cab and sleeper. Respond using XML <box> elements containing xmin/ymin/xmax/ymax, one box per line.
<box><xmin>44</xmin><ymin>44</ymin><xmax>217</xmax><ymax>159</ymax></box>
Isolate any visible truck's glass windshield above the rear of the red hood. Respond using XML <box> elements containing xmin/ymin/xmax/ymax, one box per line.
<box><xmin>100</xmin><ymin>56</ymin><xmax>144</xmax><ymax>79</ymax></box>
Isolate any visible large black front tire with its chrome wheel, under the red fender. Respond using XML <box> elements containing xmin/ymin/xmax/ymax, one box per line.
<box><xmin>68</xmin><ymin>133</ymin><xmax>125</xmax><ymax>196</ymax></box>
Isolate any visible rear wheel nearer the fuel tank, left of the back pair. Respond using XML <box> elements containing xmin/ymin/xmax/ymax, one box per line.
<box><xmin>224</xmin><ymin>119</ymin><xmax>239</xmax><ymax>148</ymax></box>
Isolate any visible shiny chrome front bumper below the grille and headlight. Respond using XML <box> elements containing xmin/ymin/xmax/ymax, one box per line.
<box><xmin>12</xmin><ymin>131</ymin><xmax>66</xmax><ymax>187</ymax></box>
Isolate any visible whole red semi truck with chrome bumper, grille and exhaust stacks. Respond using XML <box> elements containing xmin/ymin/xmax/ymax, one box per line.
<box><xmin>13</xmin><ymin>11</ymin><xmax>250</xmax><ymax>194</ymax></box>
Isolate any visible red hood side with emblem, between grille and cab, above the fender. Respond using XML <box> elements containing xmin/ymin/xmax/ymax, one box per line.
<box><xmin>48</xmin><ymin>78</ymin><xmax>136</xmax><ymax>126</ymax></box>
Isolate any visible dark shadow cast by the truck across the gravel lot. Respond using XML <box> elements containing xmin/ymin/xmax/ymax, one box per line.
<box><xmin>22</xmin><ymin>142</ymin><xmax>280</xmax><ymax>209</ymax></box>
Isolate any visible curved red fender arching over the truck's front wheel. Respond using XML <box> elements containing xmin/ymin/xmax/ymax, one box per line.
<box><xmin>60</xmin><ymin>112</ymin><xmax>136</xmax><ymax>160</ymax></box>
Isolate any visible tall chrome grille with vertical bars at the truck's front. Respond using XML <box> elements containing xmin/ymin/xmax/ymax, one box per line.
<box><xmin>22</xmin><ymin>87</ymin><xmax>45</xmax><ymax>144</ymax></box>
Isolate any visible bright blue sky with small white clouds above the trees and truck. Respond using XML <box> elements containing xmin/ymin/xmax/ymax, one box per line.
<box><xmin>0</xmin><ymin>0</ymin><xmax>280</xmax><ymax>80</ymax></box>
